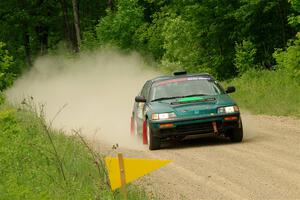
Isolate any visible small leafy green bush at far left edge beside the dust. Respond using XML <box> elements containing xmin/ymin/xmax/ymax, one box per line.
<box><xmin>0</xmin><ymin>42</ymin><xmax>14</xmax><ymax>90</ymax></box>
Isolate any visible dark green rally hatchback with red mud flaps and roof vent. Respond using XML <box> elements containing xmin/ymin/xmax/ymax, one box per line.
<box><xmin>131</xmin><ymin>72</ymin><xmax>243</xmax><ymax>150</ymax></box>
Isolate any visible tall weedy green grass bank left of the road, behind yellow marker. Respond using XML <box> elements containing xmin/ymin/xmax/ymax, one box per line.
<box><xmin>0</xmin><ymin>102</ymin><xmax>147</xmax><ymax>199</ymax></box>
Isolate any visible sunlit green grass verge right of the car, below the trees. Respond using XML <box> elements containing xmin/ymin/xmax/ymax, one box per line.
<box><xmin>224</xmin><ymin>71</ymin><xmax>300</xmax><ymax>117</ymax></box>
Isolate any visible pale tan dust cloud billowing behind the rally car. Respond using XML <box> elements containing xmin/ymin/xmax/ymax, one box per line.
<box><xmin>6</xmin><ymin>50</ymin><xmax>157</xmax><ymax>148</ymax></box>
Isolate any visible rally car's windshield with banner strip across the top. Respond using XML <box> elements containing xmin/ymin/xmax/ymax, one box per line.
<box><xmin>150</xmin><ymin>76</ymin><xmax>224</xmax><ymax>101</ymax></box>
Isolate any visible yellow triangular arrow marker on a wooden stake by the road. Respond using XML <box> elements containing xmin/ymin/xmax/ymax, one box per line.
<box><xmin>105</xmin><ymin>157</ymin><xmax>171</xmax><ymax>190</ymax></box>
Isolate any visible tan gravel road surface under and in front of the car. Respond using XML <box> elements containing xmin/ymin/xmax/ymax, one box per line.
<box><xmin>98</xmin><ymin>114</ymin><xmax>300</xmax><ymax>200</ymax></box>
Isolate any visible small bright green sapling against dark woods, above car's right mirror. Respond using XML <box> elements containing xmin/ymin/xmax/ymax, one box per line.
<box><xmin>234</xmin><ymin>40</ymin><xmax>256</xmax><ymax>74</ymax></box>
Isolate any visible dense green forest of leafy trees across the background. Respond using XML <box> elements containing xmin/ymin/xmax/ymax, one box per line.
<box><xmin>0</xmin><ymin>0</ymin><xmax>300</xmax><ymax>90</ymax></box>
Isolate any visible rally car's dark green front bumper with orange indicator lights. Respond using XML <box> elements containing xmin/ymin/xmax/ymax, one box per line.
<box><xmin>150</xmin><ymin>113</ymin><xmax>241</xmax><ymax>139</ymax></box>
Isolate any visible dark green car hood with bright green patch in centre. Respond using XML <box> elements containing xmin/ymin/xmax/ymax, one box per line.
<box><xmin>149</xmin><ymin>94</ymin><xmax>236</xmax><ymax>117</ymax></box>
